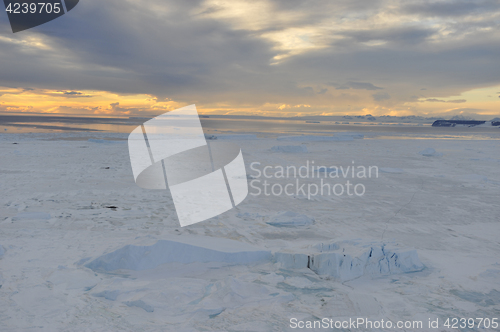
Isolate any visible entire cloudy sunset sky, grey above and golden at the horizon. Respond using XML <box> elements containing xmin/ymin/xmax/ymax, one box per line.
<box><xmin>0</xmin><ymin>0</ymin><xmax>500</xmax><ymax>119</ymax></box>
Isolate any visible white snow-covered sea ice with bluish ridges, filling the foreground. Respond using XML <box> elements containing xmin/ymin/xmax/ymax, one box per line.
<box><xmin>0</xmin><ymin>133</ymin><xmax>500</xmax><ymax>332</ymax></box>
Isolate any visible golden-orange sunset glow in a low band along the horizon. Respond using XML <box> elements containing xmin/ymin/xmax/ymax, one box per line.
<box><xmin>0</xmin><ymin>86</ymin><xmax>500</xmax><ymax>117</ymax></box>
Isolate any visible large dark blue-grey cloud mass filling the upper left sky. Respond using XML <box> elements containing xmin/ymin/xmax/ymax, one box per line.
<box><xmin>0</xmin><ymin>0</ymin><xmax>294</xmax><ymax>104</ymax></box>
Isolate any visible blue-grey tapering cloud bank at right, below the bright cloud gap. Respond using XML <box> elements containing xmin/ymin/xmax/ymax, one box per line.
<box><xmin>283</xmin><ymin>32</ymin><xmax>500</xmax><ymax>95</ymax></box>
